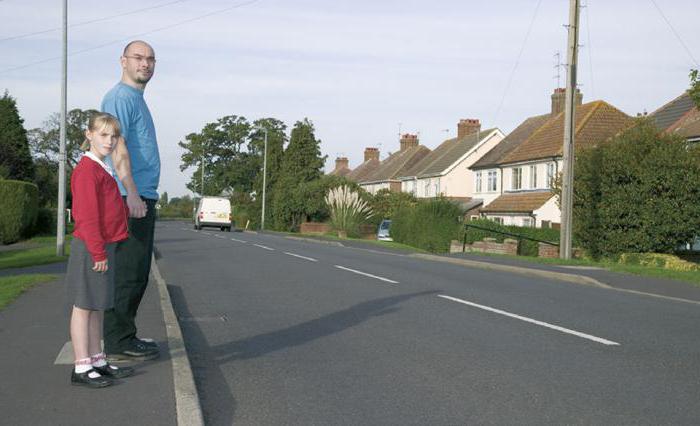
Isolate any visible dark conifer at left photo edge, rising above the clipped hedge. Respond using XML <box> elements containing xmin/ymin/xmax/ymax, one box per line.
<box><xmin>0</xmin><ymin>91</ymin><xmax>34</xmax><ymax>182</ymax></box>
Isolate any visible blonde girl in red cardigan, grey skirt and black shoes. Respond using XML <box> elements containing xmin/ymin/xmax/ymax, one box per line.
<box><xmin>66</xmin><ymin>113</ymin><xmax>134</xmax><ymax>388</ymax></box>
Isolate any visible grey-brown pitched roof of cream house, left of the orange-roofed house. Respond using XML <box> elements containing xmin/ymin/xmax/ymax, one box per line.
<box><xmin>402</xmin><ymin>128</ymin><xmax>497</xmax><ymax>177</ymax></box>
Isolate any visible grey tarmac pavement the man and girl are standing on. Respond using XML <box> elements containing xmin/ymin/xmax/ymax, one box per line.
<box><xmin>0</xmin><ymin>263</ymin><xmax>177</xmax><ymax>425</ymax></box>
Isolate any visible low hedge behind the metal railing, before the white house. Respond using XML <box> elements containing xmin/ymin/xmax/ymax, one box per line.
<box><xmin>459</xmin><ymin>219</ymin><xmax>560</xmax><ymax>256</ymax></box>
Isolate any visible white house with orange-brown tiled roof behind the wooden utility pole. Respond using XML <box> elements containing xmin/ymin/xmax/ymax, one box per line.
<box><xmin>472</xmin><ymin>89</ymin><xmax>633</xmax><ymax>227</ymax></box>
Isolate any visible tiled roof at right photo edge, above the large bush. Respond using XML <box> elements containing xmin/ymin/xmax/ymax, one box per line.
<box><xmin>649</xmin><ymin>92</ymin><xmax>700</xmax><ymax>143</ymax></box>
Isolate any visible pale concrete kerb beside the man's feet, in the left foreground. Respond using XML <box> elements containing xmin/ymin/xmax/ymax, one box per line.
<box><xmin>151</xmin><ymin>255</ymin><xmax>204</xmax><ymax>426</ymax></box>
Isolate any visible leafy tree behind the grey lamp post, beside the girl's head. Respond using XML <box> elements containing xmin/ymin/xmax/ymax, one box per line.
<box><xmin>29</xmin><ymin>108</ymin><xmax>99</xmax><ymax>172</ymax></box>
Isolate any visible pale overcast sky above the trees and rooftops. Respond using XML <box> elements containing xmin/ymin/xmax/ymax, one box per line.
<box><xmin>0</xmin><ymin>0</ymin><xmax>700</xmax><ymax>197</ymax></box>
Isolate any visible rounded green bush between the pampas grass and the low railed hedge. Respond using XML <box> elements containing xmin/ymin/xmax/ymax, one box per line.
<box><xmin>391</xmin><ymin>198</ymin><xmax>462</xmax><ymax>253</ymax></box>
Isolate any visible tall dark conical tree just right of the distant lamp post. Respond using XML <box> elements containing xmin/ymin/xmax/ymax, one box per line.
<box><xmin>272</xmin><ymin>118</ymin><xmax>326</xmax><ymax>231</ymax></box>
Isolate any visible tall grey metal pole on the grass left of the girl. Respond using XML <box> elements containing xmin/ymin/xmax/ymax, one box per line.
<box><xmin>56</xmin><ymin>0</ymin><xmax>68</xmax><ymax>256</ymax></box>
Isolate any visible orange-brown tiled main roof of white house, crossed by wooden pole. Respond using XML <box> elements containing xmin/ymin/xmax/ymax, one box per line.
<box><xmin>499</xmin><ymin>101</ymin><xmax>634</xmax><ymax>163</ymax></box>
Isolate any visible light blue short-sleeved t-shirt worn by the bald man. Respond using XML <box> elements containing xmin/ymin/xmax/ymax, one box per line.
<box><xmin>102</xmin><ymin>82</ymin><xmax>160</xmax><ymax>200</ymax></box>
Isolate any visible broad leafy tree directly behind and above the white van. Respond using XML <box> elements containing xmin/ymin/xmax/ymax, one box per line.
<box><xmin>178</xmin><ymin>115</ymin><xmax>257</xmax><ymax>195</ymax></box>
